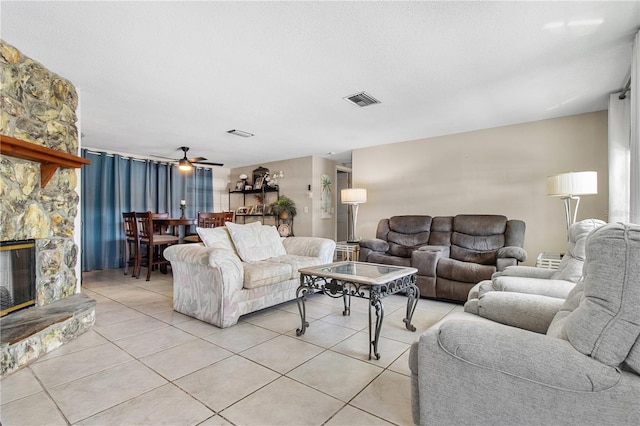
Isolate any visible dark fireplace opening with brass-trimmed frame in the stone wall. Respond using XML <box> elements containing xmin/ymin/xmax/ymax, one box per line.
<box><xmin>0</xmin><ymin>240</ymin><xmax>36</xmax><ymax>317</ymax></box>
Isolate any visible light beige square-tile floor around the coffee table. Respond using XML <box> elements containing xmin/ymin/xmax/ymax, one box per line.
<box><xmin>0</xmin><ymin>270</ymin><xmax>462</xmax><ymax>426</ymax></box>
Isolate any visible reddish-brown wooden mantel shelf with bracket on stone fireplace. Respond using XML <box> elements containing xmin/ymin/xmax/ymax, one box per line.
<box><xmin>0</xmin><ymin>135</ymin><xmax>91</xmax><ymax>188</ymax></box>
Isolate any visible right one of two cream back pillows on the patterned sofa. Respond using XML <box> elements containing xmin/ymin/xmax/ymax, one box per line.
<box><xmin>225</xmin><ymin>222</ymin><xmax>287</xmax><ymax>262</ymax></box>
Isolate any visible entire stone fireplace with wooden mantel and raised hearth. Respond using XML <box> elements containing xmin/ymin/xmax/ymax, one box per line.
<box><xmin>0</xmin><ymin>40</ymin><xmax>95</xmax><ymax>376</ymax></box>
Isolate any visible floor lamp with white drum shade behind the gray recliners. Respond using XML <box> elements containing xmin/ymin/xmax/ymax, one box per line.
<box><xmin>547</xmin><ymin>172</ymin><xmax>598</xmax><ymax>236</ymax></box>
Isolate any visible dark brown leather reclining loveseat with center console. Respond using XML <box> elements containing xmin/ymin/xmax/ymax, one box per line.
<box><xmin>359</xmin><ymin>215</ymin><xmax>527</xmax><ymax>302</ymax></box>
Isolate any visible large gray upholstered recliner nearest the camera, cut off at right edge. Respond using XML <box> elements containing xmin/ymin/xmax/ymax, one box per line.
<box><xmin>409</xmin><ymin>224</ymin><xmax>640</xmax><ymax>425</ymax></box>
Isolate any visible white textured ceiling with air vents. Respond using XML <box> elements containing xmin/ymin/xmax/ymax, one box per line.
<box><xmin>0</xmin><ymin>0</ymin><xmax>640</xmax><ymax>167</ymax></box>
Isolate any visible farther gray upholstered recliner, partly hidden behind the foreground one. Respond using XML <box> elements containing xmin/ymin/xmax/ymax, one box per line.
<box><xmin>464</xmin><ymin>219</ymin><xmax>605</xmax><ymax>333</ymax></box>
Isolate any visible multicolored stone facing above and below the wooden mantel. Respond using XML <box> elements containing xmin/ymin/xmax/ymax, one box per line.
<box><xmin>0</xmin><ymin>40</ymin><xmax>79</xmax><ymax>305</ymax></box>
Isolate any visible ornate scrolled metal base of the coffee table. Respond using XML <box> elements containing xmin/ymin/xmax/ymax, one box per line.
<box><xmin>296</xmin><ymin>274</ymin><xmax>420</xmax><ymax>359</ymax></box>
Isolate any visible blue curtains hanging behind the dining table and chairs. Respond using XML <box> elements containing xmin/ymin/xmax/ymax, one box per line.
<box><xmin>81</xmin><ymin>149</ymin><xmax>213</xmax><ymax>271</ymax></box>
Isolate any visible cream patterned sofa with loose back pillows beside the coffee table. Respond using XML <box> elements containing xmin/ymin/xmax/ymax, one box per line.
<box><xmin>164</xmin><ymin>222</ymin><xmax>336</xmax><ymax>328</ymax></box>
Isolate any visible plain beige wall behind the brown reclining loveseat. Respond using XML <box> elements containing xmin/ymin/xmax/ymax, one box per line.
<box><xmin>352</xmin><ymin>111</ymin><xmax>608</xmax><ymax>264</ymax></box>
